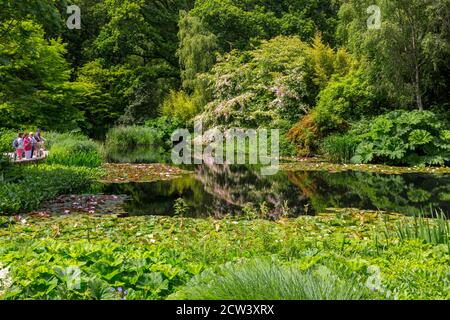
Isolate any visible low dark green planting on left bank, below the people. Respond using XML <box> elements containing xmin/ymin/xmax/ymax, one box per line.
<box><xmin>0</xmin><ymin>165</ymin><xmax>100</xmax><ymax>214</ymax></box>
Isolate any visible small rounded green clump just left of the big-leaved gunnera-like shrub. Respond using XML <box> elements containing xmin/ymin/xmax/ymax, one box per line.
<box><xmin>321</xmin><ymin>134</ymin><xmax>359</xmax><ymax>163</ymax></box>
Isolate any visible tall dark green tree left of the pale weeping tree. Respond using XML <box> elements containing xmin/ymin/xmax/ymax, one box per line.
<box><xmin>75</xmin><ymin>0</ymin><xmax>191</xmax><ymax>125</ymax></box>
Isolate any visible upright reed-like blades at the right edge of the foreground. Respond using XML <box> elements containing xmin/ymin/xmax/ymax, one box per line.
<box><xmin>385</xmin><ymin>210</ymin><xmax>450</xmax><ymax>245</ymax></box>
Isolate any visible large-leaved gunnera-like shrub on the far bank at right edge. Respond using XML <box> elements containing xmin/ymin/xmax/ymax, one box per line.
<box><xmin>352</xmin><ymin>110</ymin><xmax>450</xmax><ymax>166</ymax></box>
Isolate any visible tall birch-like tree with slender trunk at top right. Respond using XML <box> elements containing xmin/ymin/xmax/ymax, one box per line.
<box><xmin>338</xmin><ymin>0</ymin><xmax>450</xmax><ymax>110</ymax></box>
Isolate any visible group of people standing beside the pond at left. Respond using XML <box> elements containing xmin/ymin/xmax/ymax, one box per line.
<box><xmin>13</xmin><ymin>129</ymin><xmax>45</xmax><ymax>161</ymax></box>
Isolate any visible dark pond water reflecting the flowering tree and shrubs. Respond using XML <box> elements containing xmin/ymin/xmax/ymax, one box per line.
<box><xmin>104</xmin><ymin>165</ymin><xmax>450</xmax><ymax>217</ymax></box>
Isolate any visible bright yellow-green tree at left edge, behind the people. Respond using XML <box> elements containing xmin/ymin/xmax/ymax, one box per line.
<box><xmin>0</xmin><ymin>21</ymin><xmax>82</xmax><ymax>130</ymax></box>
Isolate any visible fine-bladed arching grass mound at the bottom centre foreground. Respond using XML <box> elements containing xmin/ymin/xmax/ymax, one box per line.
<box><xmin>169</xmin><ymin>259</ymin><xmax>370</xmax><ymax>300</ymax></box>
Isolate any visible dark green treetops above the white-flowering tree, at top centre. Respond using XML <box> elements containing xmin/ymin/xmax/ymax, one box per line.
<box><xmin>190</xmin><ymin>0</ymin><xmax>338</xmax><ymax>52</ymax></box>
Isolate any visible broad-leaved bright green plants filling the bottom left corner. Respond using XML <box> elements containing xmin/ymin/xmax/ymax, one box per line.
<box><xmin>0</xmin><ymin>240</ymin><xmax>189</xmax><ymax>300</ymax></box>
